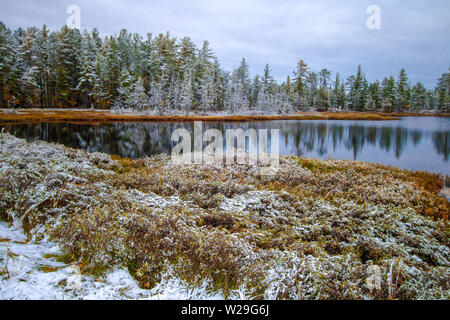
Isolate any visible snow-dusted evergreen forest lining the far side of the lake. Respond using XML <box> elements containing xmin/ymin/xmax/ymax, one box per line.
<box><xmin>0</xmin><ymin>22</ymin><xmax>450</xmax><ymax>113</ymax></box>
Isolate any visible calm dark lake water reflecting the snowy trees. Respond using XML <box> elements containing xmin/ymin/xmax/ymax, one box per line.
<box><xmin>0</xmin><ymin>117</ymin><xmax>450</xmax><ymax>175</ymax></box>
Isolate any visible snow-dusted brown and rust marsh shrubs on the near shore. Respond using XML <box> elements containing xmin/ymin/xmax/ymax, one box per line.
<box><xmin>0</xmin><ymin>134</ymin><xmax>450</xmax><ymax>299</ymax></box>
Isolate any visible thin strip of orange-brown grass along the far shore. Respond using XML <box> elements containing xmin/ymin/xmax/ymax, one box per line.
<box><xmin>0</xmin><ymin>109</ymin><xmax>450</xmax><ymax>123</ymax></box>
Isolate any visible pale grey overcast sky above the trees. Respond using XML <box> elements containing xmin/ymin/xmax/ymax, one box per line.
<box><xmin>0</xmin><ymin>0</ymin><xmax>450</xmax><ymax>87</ymax></box>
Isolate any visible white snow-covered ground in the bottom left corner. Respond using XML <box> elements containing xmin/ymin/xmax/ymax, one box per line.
<box><xmin>0</xmin><ymin>222</ymin><xmax>229</xmax><ymax>300</ymax></box>
